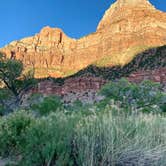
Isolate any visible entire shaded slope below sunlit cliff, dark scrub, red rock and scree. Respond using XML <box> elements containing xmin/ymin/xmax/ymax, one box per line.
<box><xmin>21</xmin><ymin>46</ymin><xmax>166</xmax><ymax>104</ymax></box>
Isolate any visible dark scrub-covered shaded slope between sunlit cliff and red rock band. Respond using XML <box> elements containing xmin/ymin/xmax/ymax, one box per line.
<box><xmin>40</xmin><ymin>45</ymin><xmax>166</xmax><ymax>84</ymax></box>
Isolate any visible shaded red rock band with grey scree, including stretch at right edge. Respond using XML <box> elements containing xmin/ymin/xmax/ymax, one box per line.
<box><xmin>23</xmin><ymin>68</ymin><xmax>166</xmax><ymax>104</ymax></box>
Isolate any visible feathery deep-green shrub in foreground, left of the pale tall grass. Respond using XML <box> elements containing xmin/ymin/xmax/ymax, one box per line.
<box><xmin>21</xmin><ymin>112</ymin><xmax>79</xmax><ymax>166</ymax></box>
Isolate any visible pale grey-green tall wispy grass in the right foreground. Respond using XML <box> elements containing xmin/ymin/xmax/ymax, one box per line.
<box><xmin>76</xmin><ymin>111</ymin><xmax>166</xmax><ymax>166</ymax></box>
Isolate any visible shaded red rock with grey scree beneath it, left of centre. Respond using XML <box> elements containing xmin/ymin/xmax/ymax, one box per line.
<box><xmin>22</xmin><ymin>76</ymin><xmax>107</xmax><ymax>104</ymax></box>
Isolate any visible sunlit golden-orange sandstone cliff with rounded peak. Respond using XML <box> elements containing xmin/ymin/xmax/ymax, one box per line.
<box><xmin>0</xmin><ymin>0</ymin><xmax>166</xmax><ymax>78</ymax></box>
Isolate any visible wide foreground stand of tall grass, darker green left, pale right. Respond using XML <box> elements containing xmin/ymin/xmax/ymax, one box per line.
<box><xmin>0</xmin><ymin>108</ymin><xmax>166</xmax><ymax>166</ymax></box>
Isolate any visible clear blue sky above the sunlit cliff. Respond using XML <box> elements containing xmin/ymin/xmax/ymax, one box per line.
<box><xmin>0</xmin><ymin>0</ymin><xmax>166</xmax><ymax>47</ymax></box>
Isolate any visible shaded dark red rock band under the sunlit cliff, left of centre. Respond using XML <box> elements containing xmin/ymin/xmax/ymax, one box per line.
<box><xmin>31</xmin><ymin>76</ymin><xmax>107</xmax><ymax>96</ymax></box>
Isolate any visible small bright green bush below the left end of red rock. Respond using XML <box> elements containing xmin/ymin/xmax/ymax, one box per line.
<box><xmin>30</xmin><ymin>95</ymin><xmax>62</xmax><ymax>115</ymax></box>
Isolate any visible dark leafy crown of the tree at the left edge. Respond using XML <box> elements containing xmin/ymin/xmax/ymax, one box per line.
<box><xmin>0</xmin><ymin>53</ymin><xmax>35</xmax><ymax>109</ymax></box>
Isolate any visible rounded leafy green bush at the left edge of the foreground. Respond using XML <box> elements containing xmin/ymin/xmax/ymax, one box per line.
<box><xmin>0</xmin><ymin>111</ymin><xmax>34</xmax><ymax>156</ymax></box>
